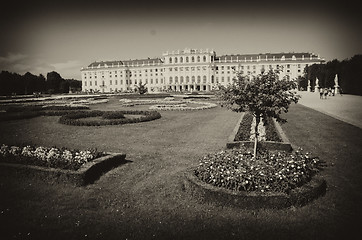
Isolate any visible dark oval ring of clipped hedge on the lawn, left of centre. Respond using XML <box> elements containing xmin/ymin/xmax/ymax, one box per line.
<box><xmin>59</xmin><ymin>110</ymin><xmax>161</xmax><ymax>126</ymax></box>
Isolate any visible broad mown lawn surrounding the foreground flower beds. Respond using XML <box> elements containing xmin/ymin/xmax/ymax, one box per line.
<box><xmin>0</xmin><ymin>98</ymin><xmax>362</xmax><ymax>239</ymax></box>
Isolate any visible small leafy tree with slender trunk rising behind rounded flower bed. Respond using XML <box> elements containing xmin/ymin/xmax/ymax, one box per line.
<box><xmin>219</xmin><ymin>70</ymin><xmax>300</xmax><ymax>157</ymax></box>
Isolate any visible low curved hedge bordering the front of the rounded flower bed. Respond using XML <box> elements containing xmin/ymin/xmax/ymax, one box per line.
<box><xmin>184</xmin><ymin>169</ymin><xmax>327</xmax><ymax>209</ymax></box>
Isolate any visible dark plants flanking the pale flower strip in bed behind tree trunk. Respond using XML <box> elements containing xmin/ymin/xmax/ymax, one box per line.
<box><xmin>234</xmin><ymin>112</ymin><xmax>282</xmax><ymax>142</ymax></box>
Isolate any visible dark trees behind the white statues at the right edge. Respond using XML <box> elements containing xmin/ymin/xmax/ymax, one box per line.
<box><xmin>298</xmin><ymin>55</ymin><xmax>362</xmax><ymax>95</ymax></box>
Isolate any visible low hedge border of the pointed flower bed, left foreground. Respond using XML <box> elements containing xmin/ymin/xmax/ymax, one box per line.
<box><xmin>0</xmin><ymin>153</ymin><xmax>126</xmax><ymax>186</ymax></box>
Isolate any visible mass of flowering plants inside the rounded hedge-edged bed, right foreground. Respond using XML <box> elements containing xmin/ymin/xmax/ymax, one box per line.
<box><xmin>194</xmin><ymin>147</ymin><xmax>323</xmax><ymax>193</ymax></box>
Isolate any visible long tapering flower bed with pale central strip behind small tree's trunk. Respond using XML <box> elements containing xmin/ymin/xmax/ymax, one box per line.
<box><xmin>226</xmin><ymin>113</ymin><xmax>293</xmax><ymax>152</ymax></box>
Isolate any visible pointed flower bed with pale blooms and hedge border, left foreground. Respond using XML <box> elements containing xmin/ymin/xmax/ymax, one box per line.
<box><xmin>0</xmin><ymin>144</ymin><xmax>126</xmax><ymax>186</ymax></box>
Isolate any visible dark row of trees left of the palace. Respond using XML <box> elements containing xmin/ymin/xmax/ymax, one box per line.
<box><xmin>0</xmin><ymin>71</ymin><xmax>82</xmax><ymax>96</ymax></box>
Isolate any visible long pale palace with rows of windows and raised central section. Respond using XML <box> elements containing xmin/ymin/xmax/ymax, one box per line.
<box><xmin>81</xmin><ymin>49</ymin><xmax>324</xmax><ymax>93</ymax></box>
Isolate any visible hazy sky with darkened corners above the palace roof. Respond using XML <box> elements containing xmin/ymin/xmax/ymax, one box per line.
<box><xmin>0</xmin><ymin>0</ymin><xmax>362</xmax><ymax>79</ymax></box>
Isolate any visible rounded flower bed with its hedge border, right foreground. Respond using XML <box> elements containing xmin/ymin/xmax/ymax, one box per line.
<box><xmin>185</xmin><ymin>147</ymin><xmax>326</xmax><ymax>209</ymax></box>
